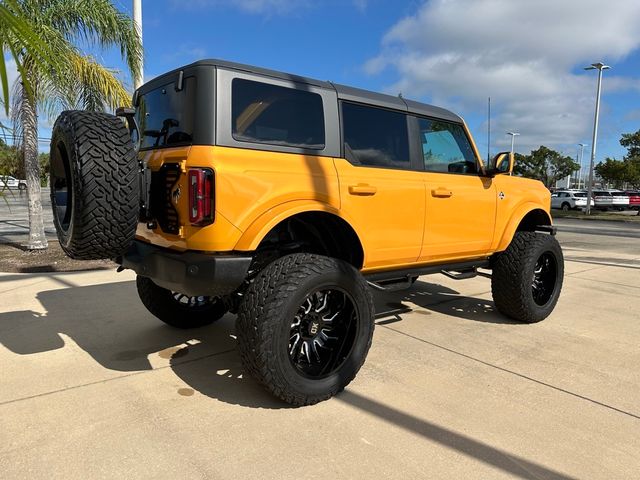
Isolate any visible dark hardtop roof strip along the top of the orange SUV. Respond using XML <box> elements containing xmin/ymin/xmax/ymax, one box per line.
<box><xmin>141</xmin><ymin>59</ymin><xmax>463</xmax><ymax>123</ymax></box>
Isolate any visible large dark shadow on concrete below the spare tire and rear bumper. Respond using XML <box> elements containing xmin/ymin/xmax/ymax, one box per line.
<box><xmin>0</xmin><ymin>281</ymin><xmax>288</xmax><ymax>408</ymax></box>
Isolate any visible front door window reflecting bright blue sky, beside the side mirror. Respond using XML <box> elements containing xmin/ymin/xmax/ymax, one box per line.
<box><xmin>418</xmin><ymin>118</ymin><xmax>478</xmax><ymax>174</ymax></box>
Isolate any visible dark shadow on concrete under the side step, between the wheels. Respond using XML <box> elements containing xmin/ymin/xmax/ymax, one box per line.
<box><xmin>374</xmin><ymin>280</ymin><xmax>518</xmax><ymax>325</ymax></box>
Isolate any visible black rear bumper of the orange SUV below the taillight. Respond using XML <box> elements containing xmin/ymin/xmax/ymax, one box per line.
<box><xmin>116</xmin><ymin>240</ymin><xmax>252</xmax><ymax>296</ymax></box>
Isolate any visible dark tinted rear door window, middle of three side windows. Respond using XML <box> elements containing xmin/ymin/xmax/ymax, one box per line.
<box><xmin>342</xmin><ymin>103</ymin><xmax>411</xmax><ymax>169</ymax></box>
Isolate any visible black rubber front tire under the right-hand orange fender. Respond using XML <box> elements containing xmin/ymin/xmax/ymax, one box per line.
<box><xmin>491</xmin><ymin>232</ymin><xmax>564</xmax><ymax>323</ymax></box>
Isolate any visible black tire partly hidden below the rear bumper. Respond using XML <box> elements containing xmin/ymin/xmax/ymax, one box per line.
<box><xmin>136</xmin><ymin>276</ymin><xmax>228</xmax><ymax>329</ymax></box>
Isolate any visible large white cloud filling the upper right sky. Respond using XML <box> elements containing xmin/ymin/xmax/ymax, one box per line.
<box><xmin>365</xmin><ymin>0</ymin><xmax>640</xmax><ymax>150</ymax></box>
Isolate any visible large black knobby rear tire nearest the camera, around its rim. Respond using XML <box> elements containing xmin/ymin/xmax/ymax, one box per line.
<box><xmin>236</xmin><ymin>253</ymin><xmax>374</xmax><ymax>406</ymax></box>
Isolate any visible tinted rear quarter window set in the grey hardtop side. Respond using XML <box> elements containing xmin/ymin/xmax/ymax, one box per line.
<box><xmin>231</xmin><ymin>78</ymin><xmax>325</xmax><ymax>150</ymax></box>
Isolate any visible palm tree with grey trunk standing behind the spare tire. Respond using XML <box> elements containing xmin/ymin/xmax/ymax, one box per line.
<box><xmin>7</xmin><ymin>0</ymin><xmax>142</xmax><ymax>249</ymax></box>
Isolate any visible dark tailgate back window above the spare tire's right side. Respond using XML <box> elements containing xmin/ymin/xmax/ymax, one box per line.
<box><xmin>136</xmin><ymin>77</ymin><xmax>196</xmax><ymax>149</ymax></box>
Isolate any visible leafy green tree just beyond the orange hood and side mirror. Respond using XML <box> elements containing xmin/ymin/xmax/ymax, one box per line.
<box><xmin>514</xmin><ymin>145</ymin><xmax>580</xmax><ymax>188</ymax></box>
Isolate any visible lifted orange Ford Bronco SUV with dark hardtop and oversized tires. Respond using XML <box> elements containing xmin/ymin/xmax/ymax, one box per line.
<box><xmin>51</xmin><ymin>60</ymin><xmax>563</xmax><ymax>405</ymax></box>
